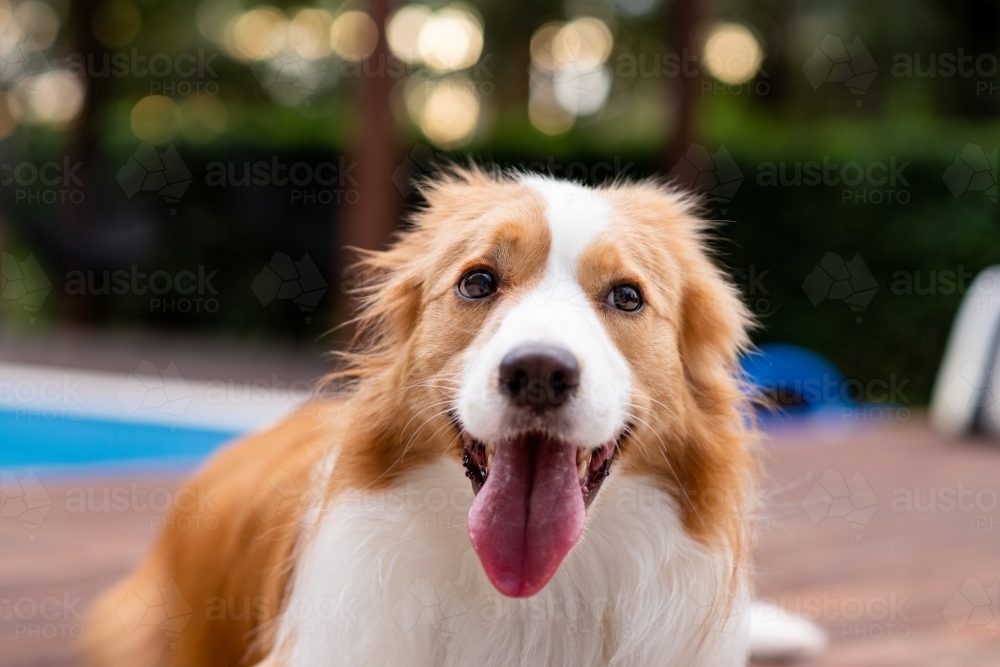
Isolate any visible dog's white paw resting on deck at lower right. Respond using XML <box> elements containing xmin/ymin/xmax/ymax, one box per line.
<box><xmin>750</xmin><ymin>602</ymin><xmax>826</xmax><ymax>663</ymax></box>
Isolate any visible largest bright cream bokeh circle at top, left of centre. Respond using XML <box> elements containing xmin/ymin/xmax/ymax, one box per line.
<box><xmin>417</xmin><ymin>3</ymin><xmax>483</xmax><ymax>72</ymax></box>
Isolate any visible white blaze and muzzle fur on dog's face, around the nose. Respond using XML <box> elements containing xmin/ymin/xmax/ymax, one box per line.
<box><xmin>458</xmin><ymin>176</ymin><xmax>631</xmax><ymax>449</ymax></box>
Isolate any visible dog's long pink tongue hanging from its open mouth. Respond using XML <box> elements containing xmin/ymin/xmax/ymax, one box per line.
<box><xmin>469</xmin><ymin>436</ymin><xmax>585</xmax><ymax>597</ymax></box>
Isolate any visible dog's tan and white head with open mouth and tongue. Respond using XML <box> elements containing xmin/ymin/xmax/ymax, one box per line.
<box><xmin>340</xmin><ymin>171</ymin><xmax>748</xmax><ymax>597</ymax></box>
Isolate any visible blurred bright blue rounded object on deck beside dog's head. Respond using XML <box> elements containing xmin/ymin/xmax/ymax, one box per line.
<box><xmin>743</xmin><ymin>343</ymin><xmax>852</xmax><ymax>417</ymax></box>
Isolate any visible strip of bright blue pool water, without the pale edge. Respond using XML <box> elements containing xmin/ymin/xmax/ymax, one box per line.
<box><xmin>0</xmin><ymin>410</ymin><xmax>239</xmax><ymax>467</ymax></box>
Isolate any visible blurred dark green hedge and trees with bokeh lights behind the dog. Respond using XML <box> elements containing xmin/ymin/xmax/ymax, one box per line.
<box><xmin>0</xmin><ymin>0</ymin><xmax>1000</xmax><ymax>404</ymax></box>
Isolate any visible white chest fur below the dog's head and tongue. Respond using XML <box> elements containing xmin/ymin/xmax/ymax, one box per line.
<box><xmin>273</xmin><ymin>459</ymin><xmax>748</xmax><ymax>667</ymax></box>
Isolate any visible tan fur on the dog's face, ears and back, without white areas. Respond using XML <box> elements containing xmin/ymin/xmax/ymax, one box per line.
<box><xmin>90</xmin><ymin>170</ymin><xmax>752</xmax><ymax>667</ymax></box>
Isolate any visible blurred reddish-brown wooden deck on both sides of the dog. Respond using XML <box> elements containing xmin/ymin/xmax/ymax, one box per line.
<box><xmin>0</xmin><ymin>417</ymin><xmax>1000</xmax><ymax>667</ymax></box>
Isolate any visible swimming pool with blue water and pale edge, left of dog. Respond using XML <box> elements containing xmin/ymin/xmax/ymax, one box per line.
<box><xmin>0</xmin><ymin>362</ymin><xmax>308</xmax><ymax>473</ymax></box>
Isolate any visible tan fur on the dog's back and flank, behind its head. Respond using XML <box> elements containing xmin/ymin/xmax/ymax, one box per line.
<box><xmin>87</xmin><ymin>402</ymin><xmax>332</xmax><ymax>667</ymax></box>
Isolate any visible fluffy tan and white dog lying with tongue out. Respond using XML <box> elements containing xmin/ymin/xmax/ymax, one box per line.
<box><xmin>87</xmin><ymin>168</ymin><xmax>823</xmax><ymax>667</ymax></box>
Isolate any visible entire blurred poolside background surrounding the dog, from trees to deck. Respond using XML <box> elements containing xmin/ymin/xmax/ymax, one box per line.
<box><xmin>0</xmin><ymin>0</ymin><xmax>1000</xmax><ymax>666</ymax></box>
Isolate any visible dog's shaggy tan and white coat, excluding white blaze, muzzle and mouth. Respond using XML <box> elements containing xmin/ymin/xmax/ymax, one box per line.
<box><xmin>88</xmin><ymin>169</ymin><xmax>820</xmax><ymax>667</ymax></box>
